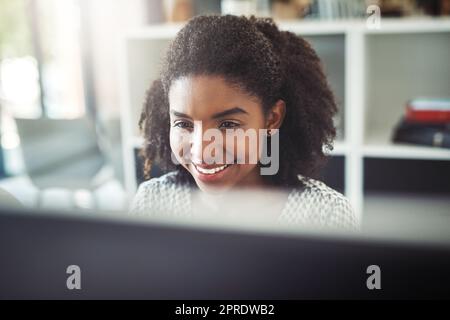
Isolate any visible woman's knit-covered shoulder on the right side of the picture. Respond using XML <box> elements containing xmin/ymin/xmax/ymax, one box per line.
<box><xmin>280</xmin><ymin>175</ymin><xmax>359</xmax><ymax>229</ymax></box>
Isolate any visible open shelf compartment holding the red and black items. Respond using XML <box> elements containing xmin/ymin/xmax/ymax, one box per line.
<box><xmin>364</xmin><ymin>29</ymin><xmax>450</xmax><ymax>151</ymax></box>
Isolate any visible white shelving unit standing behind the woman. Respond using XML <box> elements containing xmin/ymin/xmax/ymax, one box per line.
<box><xmin>120</xmin><ymin>18</ymin><xmax>450</xmax><ymax>220</ymax></box>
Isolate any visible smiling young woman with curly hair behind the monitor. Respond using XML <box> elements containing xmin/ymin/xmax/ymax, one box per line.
<box><xmin>132</xmin><ymin>15</ymin><xmax>358</xmax><ymax>228</ymax></box>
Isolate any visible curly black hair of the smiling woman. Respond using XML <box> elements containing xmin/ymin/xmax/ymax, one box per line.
<box><xmin>139</xmin><ymin>15</ymin><xmax>337</xmax><ymax>186</ymax></box>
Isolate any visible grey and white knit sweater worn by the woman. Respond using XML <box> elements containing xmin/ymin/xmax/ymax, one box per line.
<box><xmin>130</xmin><ymin>172</ymin><xmax>359</xmax><ymax>229</ymax></box>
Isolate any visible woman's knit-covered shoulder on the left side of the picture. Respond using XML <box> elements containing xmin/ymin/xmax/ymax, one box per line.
<box><xmin>130</xmin><ymin>171</ymin><xmax>190</xmax><ymax>215</ymax></box>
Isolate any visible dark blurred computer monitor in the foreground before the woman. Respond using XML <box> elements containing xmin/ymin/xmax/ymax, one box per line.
<box><xmin>0</xmin><ymin>208</ymin><xmax>450</xmax><ymax>300</ymax></box>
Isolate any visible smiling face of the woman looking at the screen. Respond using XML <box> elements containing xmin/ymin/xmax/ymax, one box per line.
<box><xmin>169</xmin><ymin>75</ymin><xmax>282</xmax><ymax>192</ymax></box>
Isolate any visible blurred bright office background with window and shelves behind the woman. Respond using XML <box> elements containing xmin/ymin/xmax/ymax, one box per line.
<box><xmin>0</xmin><ymin>0</ymin><xmax>450</xmax><ymax>222</ymax></box>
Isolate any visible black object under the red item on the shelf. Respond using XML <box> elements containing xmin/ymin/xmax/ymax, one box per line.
<box><xmin>392</xmin><ymin>119</ymin><xmax>450</xmax><ymax>149</ymax></box>
